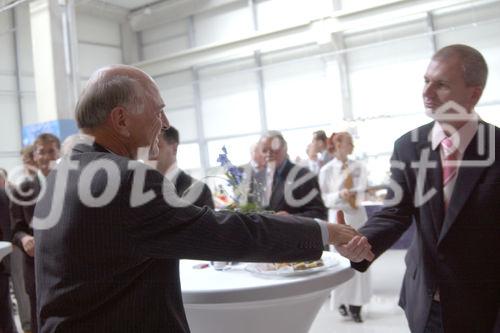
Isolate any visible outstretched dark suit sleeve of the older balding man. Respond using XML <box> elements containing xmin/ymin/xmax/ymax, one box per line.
<box><xmin>120</xmin><ymin>165</ymin><xmax>323</xmax><ymax>261</ymax></box>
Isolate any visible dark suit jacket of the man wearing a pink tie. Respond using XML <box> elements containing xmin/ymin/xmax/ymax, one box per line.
<box><xmin>352</xmin><ymin>121</ymin><xmax>500</xmax><ymax>333</ymax></box>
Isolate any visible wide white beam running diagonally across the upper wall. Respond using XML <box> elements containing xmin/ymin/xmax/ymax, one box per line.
<box><xmin>135</xmin><ymin>0</ymin><xmax>490</xmax><ymax>76</ymax></box>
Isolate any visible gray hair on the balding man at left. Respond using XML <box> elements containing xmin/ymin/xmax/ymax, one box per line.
<box><xmin>75</xmin><ymin>67</ymin><xmax>145</xmax><ymax>128</ymax></box>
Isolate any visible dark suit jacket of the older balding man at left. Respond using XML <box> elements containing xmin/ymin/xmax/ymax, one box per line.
<box><xmin>35</xmin><ymin>144</ymin><xmax>323</xmax><ymax>333</ymax></box>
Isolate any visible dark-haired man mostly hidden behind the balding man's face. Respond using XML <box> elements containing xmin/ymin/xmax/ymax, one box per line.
<box><xmin>156</xmin><ymin>126</ymin><xmax>214</xmax><ymax>208</ymax></box>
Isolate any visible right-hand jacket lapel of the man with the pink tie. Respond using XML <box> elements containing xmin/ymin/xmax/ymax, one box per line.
<box><xmin>438</xmin><ymin>126</ymin><xmax>487</xmax><ymax>244</ymax></box>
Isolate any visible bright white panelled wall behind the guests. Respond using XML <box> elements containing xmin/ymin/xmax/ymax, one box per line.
<box><xmin>141</xmin><ymin>0</ymin><xmax>500</xmax><ymax>183</ymax></box>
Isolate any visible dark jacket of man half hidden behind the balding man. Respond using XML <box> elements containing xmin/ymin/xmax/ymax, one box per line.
<box><xmin>174</xmin><ymin>170</ymin><xmax>214</xmax><ymax>209</ymax></box>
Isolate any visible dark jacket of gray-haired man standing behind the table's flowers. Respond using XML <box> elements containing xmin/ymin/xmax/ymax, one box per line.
<box><xmin>266</xmin><ymin>159</ymin><xmax>327</xmax><ymax>220</ymax></box>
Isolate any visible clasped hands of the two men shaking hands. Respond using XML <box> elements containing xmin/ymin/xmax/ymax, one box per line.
<box><xmin>328</xmin><ymin>211</ymin><xmax>375</xmax><ymax>262</ymax></box>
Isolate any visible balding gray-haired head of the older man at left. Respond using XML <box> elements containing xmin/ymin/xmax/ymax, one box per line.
<box><xmin>76</xmin><ymin>65</ymin><xmax>168</xmax><ymax>159</ymax></box>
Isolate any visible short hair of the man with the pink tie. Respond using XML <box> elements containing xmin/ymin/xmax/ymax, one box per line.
<box><xmin>432</xmin><ymin>44</ymin><xmax>488</xmax><ymax>89</ymax></box>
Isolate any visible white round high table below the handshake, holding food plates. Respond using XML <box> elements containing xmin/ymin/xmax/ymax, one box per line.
<box><xmin>180</xmin><ymin>252</ymin><xmax>354</xmax><ymax>333</ymax></box>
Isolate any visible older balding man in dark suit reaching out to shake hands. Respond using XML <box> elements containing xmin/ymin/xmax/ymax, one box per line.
<box><xmin>34</xmin><ymin>65</ymin><xmax>372</xmax><ymax>333</ymax></box>
